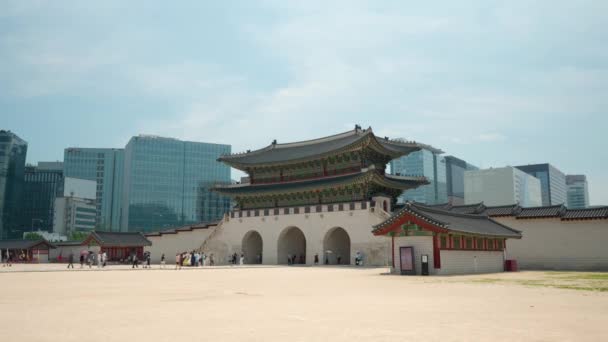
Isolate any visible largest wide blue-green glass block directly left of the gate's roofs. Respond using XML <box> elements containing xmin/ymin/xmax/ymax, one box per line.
<box><xmin>121</xmin><ymin>135</ymin><xmax>231</xmax><ymax>231</ymax></box>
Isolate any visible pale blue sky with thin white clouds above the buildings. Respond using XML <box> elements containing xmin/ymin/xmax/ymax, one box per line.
<box><xmin>0</xmin><ymin>0</ymin><xmax>608</xmax><ymax>204</ymax></box>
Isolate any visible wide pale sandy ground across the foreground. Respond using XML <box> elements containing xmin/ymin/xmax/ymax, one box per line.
<box><xmin>0</xmin><ymin>265</ymin><xmax>608</xmax><ymax>342</ymax></box>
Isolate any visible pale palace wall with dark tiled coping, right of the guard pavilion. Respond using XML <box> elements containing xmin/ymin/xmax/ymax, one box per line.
<box><xmin>428</xmin><ymin>203</ymin><xmax>608</xmax><ymax>271</ymax></box>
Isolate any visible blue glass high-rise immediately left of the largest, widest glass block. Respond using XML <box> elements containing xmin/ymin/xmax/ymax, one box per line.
<box><xmin>64</xmin><ymin>147</ymin><xmax>124</xmax><ymax>231</ymax></box>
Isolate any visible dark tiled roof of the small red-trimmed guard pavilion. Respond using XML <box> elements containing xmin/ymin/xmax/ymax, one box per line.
<box><xmin>373</xmin><ymin>203</ymin><xmax>521</xmax><ymax>238</ymax></box>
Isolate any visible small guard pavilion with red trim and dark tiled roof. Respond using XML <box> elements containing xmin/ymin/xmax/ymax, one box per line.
<box><xmin>373</xmin><ymin>203</ymin><xmax>522</xmax><ymax>275</ymax></box>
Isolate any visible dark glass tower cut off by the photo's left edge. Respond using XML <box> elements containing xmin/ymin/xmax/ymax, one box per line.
<box><xmin>0</xmin><ymin>130</ymin><xmax>27</xmax><ymax>239</ymax></box>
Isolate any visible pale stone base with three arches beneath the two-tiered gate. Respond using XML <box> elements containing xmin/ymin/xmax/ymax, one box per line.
<box><xmin>204</xmin><ymin>202</ymin><xmax>390</xmax><ymax>266</ymax></box>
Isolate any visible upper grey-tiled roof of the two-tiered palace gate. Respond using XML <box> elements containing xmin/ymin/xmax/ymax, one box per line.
<box><xmin>218</xmin><ymin>127</ymin><xmax>442</xmax><ymax>169</ymax></box>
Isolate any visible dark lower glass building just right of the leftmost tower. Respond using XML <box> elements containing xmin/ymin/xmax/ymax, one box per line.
<box><xmin>19</xmin><ymin>162</ymin><xmax>64</xmax><ymax>232</ymax></box>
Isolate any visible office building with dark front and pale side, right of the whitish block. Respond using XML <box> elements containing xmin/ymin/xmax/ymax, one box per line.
<box><xmin>516</xmin><ymin>164</ymin><xmax>567</xmax><ymax>206</ymax></box>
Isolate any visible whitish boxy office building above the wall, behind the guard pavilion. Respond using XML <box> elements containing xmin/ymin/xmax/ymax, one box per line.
<box><xmin>464</xmin><ymin>166</ymin><xmax>542</xmax><ymax>207</ymax></box>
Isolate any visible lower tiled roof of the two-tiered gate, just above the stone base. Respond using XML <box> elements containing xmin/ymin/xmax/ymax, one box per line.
<box><xmin>213</xmin><ymin>168</ymin><xmax>428</xmax><ymax>196</ymax></box>
